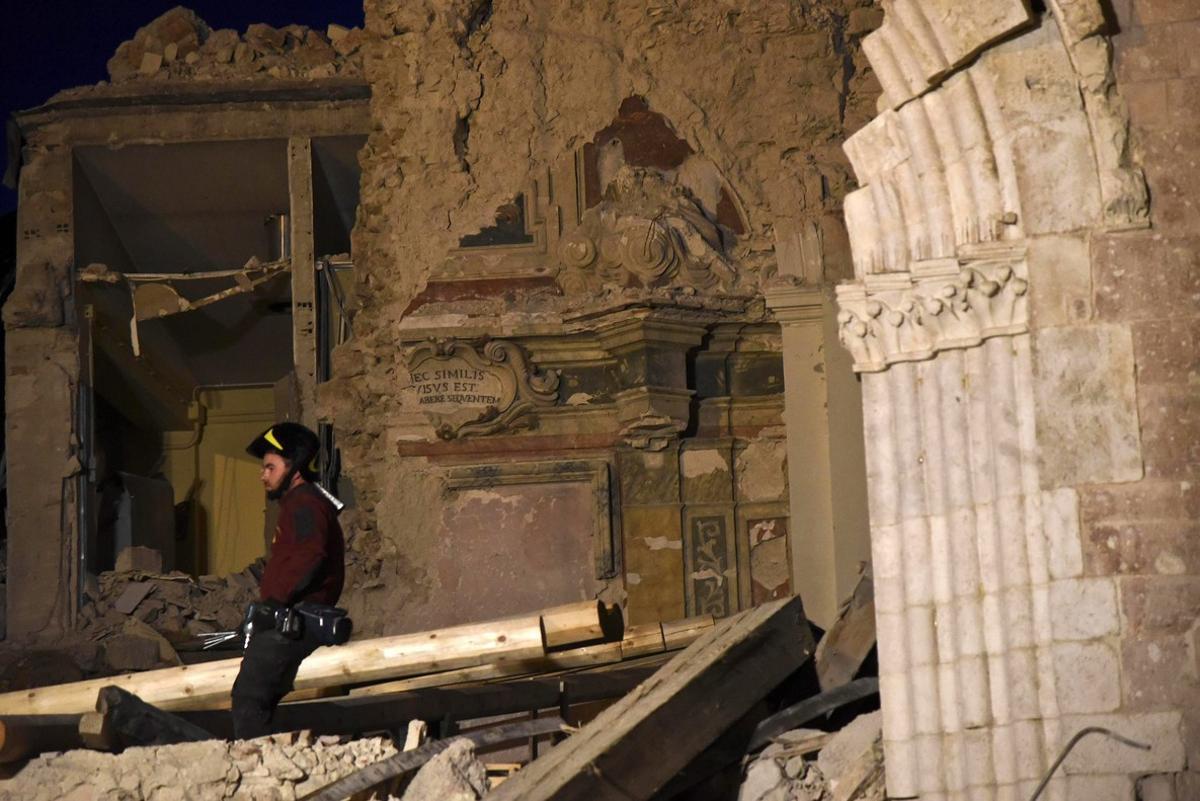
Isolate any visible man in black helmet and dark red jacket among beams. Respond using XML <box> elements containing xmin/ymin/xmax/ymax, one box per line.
<box><xmin>233</xmin><ymin>422</ymin><xmax>344</xmax><ymax>740</ymax></box>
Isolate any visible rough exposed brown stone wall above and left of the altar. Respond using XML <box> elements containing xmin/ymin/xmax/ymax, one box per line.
<box><xmin>320</xmin><ymin>0</ymin><xmax>881</xmax><ymax>633</ymax></box>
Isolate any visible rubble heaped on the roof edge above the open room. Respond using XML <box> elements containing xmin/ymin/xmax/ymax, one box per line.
<box><xmin>108</xmin><ymin>6</ymin><xmax>366</xmax><ymax>84</ymax></box>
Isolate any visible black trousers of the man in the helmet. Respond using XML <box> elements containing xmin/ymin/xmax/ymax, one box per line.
<box><xmin>233</xmin><ymin>630</ymin><xmax>318</xmax><ymax>740</ymax></box>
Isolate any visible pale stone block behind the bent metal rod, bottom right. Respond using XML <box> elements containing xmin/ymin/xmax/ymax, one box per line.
<box><xmin>1054</xmin><ymin>711</ymin><xmax>1183</xmax><ymax>775</ymax></box>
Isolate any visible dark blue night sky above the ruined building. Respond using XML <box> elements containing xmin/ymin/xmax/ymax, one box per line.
<box><xmin>0</xmin><ymin>0</ymin><xmax>362</xmax><ymax>213</ymax></box>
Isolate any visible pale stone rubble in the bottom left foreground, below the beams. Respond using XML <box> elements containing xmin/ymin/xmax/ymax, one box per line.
<box><xmin>0</xmin><ymin>731</ymin><xmax>488</xmax><ymax>801</ymax></box>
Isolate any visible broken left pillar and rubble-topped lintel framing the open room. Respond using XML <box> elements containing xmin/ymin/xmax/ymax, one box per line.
<box><xmin>4</xmin><ymin>8</ymin><xmax>366</xmax><ymax>640</ymax></box>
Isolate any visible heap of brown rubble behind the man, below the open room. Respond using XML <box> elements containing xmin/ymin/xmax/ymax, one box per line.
<box><xmin>79</xmin><ymin>560</ymin><xmax>263</xmax><ymax>673</ymax></box>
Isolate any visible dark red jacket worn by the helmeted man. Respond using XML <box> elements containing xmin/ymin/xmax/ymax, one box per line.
<box><xmin>258</xmin><ymin>482</ymin><xmax>346</xmax><ymax>606</ymax></box>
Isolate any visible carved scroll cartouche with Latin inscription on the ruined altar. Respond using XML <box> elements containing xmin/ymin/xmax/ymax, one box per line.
<box><xmin>403</xmin><ymin>339</ymin><xmax>559</xmax><ymax>440</ymax></box>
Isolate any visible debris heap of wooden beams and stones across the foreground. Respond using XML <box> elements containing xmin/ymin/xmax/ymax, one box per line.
<box><xmin>0</xmin><ymin>587</ymin><xmax>883</xmax><ymax>801</ymax></box>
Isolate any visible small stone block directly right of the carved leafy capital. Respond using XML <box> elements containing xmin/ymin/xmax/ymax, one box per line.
<box><xmin>1026</xmin><ymin>234</ymin><xmax>1092</xmax><ymax>327</ymax></box>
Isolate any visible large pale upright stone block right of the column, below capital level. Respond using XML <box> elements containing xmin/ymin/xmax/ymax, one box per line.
<box><xmin>1036</xmin><ymin>325</ymin><xmax>1142</xmax><ymax>488</ymax></box>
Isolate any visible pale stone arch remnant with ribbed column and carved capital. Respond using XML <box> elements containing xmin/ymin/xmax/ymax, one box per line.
<box><xmin>838</xmin><ymin>0</ymin><xmax>1184</xmax><ymax>799</ymax></box>
